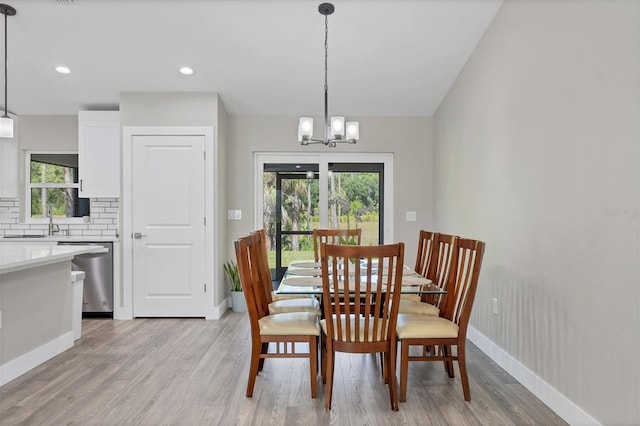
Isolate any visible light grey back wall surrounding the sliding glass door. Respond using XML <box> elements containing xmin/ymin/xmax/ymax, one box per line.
<box><xmin>227</xmin><ymin>116</ymin><xmax>433</xmax><ymax>264</ymax></box>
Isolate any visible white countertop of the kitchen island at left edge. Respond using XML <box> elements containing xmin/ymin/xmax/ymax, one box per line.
<box><xmin>0</xmin><ymin>244</ymin><xmax>105</xmax><ymax>274</ymax></box>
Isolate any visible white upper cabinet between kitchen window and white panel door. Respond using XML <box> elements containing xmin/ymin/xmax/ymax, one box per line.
<box><xmin>78</xmin><ymin>111</ymin><xmax>120</xmax><ymax>198</ymax></box>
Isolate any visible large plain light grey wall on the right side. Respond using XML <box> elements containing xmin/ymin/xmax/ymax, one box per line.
<box><xmin>434</xmin><ymin>0</ymin><xmax>640</xmax><ymax>424</ymax></box>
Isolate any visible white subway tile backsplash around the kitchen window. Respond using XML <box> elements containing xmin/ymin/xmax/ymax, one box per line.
<box><xmin>0</xmin><ymin>198</ymin><xmax>120</xmax><ymax>237</ymax></box>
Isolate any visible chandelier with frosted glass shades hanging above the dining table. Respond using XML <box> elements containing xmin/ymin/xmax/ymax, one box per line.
<box><xmin>298</xmin><ymin>3</ymin><xmax>360</xmax><ymax>148</ymax></box>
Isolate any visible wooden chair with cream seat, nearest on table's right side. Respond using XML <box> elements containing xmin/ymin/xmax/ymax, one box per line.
<box><xmin>397</xmin><ymin>238</ymin><xmax>485</xmax><ymax>402</ymax></box>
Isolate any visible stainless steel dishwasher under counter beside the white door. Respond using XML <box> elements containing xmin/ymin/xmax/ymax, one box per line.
<box><xmin>58</xmin><ymin>241</ymin><xmax>113</xmax><ymax>315</ymax></box>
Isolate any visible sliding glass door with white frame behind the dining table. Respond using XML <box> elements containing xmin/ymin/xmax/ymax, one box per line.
<box><xmin>256</xmin><ymin>154</ymin><xmax>392</xmax><ymax>281</ymax></box>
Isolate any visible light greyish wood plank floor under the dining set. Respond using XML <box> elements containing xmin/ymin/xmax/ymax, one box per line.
<box><xmin>0</xmin><ymin>312</ymin><xmax>565</xmax><ymax>426</ymax></box>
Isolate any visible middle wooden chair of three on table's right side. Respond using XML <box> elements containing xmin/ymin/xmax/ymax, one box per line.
<box><xmin>399</xmin><ymin>233</ymin><xmax>458</xmax><ymax>316</ymax></box>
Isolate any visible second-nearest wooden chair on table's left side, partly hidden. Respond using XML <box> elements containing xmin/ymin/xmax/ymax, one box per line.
<box><xmin>251</xmin><ymin>229</ymin><xmax>321</xmax><ymax>316</ymax></box>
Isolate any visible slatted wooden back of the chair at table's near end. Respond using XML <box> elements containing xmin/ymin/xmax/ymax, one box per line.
<box><xmin>320</xmin><ymin>243</ymin><xmax>404</xmax><ymax>344</ymax></box>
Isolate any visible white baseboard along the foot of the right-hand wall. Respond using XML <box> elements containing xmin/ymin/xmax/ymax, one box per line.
<box><xmin>467</xmin><ymin>326</ymin><xmax>600</xmax><ymax>425</ymax></box>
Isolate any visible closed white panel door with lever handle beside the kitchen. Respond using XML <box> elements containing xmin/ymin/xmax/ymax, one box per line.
<box><xmin>131</xmin><ymin>135</ymin><xmax>206</xmax><ymax>317</ymax></box>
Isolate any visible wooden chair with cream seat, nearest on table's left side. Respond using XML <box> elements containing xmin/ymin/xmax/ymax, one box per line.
<box><xmin>234</xmin><ymin>235</ymin><xmax>320</xmax><ymax>398</ymax></box>
